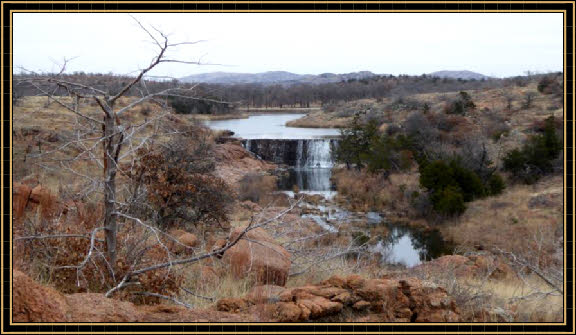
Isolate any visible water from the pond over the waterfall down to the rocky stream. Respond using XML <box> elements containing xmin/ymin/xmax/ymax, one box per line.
<box><xmin>205</xmin><ymin>114</ymin><xmax>451</xmax><ymax>267</ymax></box>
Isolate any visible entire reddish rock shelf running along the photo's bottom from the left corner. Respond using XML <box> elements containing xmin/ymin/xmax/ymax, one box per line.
<box><xmin>12</xmin><ymin>270</ymin><xmax>462</xmax><ymax>322</ymax></box>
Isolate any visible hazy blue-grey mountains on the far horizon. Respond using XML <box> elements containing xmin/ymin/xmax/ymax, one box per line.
<box><xmin>180</xmin><ymin>71</ymin><xmax>489</xmax><ymax>85</ymax></box>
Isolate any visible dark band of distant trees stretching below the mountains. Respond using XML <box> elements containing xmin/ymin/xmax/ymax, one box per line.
<box><xmin>13</xmin><ymin>73</ymin><xmax>562</xmax><ymax>108</ymax></box>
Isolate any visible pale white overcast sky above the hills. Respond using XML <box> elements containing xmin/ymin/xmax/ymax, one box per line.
<box><xmin>13</xmin><ymin>13</ymin><xmax>563</xmax><ymax>77</ymax></box>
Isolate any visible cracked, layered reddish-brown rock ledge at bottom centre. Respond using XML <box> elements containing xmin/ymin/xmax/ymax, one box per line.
<box><xmin>217</xmin><ymin>275</ymin><xmax>460</xmax><ymax>322</ymax></box>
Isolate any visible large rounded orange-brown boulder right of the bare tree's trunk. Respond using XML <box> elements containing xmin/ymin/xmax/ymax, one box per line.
<box><xmin>223</xmin><ymin>227</ymin><xmax>291</xmax><ymax>286</ymax></box>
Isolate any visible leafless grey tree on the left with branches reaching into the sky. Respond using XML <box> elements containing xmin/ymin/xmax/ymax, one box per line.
<box><xmin>17</xmin><ymin>18</ymin><xmax>212</xmax><ymax>265</ymax></box>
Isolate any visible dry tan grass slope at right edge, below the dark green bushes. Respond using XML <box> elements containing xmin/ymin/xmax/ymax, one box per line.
<box><xmin>441</xmin><ymin>176</ymin><xmax>563</xmax><ymax>265</ymax></box>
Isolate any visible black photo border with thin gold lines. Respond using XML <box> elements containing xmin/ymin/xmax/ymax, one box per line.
<box><xmin>1</xmin><ymin>1</ymin><xmax>575</xmax><ymax>334</ymax></box>
